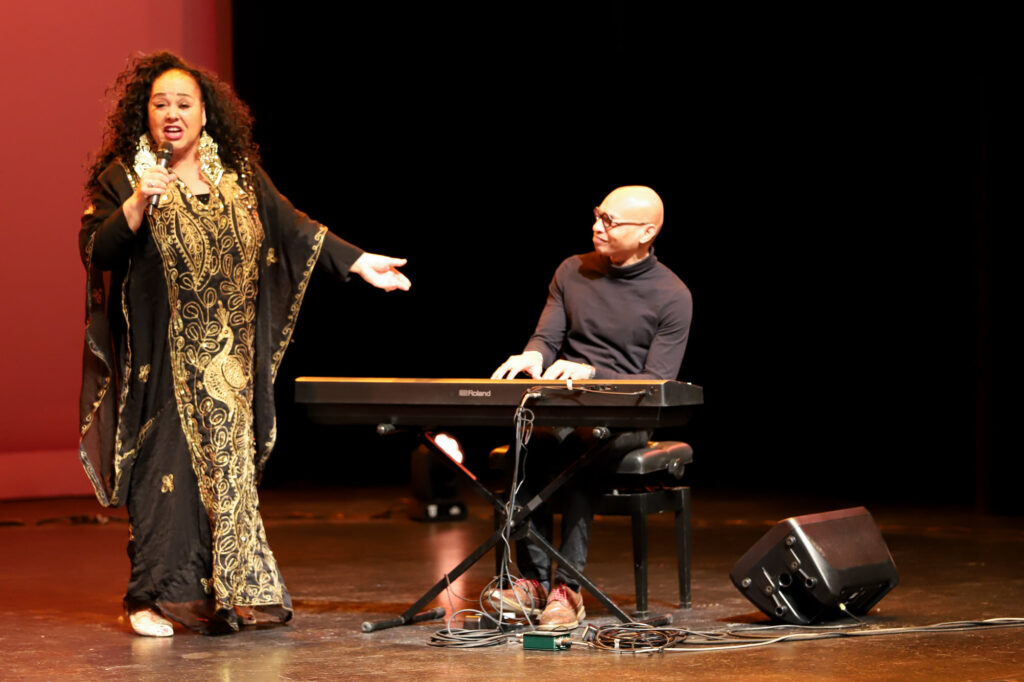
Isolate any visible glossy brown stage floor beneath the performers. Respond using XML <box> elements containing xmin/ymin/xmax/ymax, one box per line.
<box><xmin>0</xmin><ymin>488</ymin><xmax>1024</xmax><ymax>681</ymax></box>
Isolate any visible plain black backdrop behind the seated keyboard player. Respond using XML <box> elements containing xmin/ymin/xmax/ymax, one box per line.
<box><xmin>234</xmin><ymin>3</ymin><xmax>1022</xmax><ymax>511</ymax></box>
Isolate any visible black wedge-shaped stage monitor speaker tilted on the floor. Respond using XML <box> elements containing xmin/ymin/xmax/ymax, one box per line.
<box><xmin>729</xmin><ymin>507</ymin><xmax>899</xmax><ymax>625</ymax></box>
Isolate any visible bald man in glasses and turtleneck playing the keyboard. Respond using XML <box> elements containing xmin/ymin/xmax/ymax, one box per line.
<box><xmin>490</xmin><ymin>186</ymin><xmax>693</xmax><ymax>630</ymax></box>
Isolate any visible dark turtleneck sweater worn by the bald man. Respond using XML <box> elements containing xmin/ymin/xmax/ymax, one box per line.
<box><xmin>525</xmin><ymin>251</ymin><xmax>693</xmax><ymax>379</ymax></box>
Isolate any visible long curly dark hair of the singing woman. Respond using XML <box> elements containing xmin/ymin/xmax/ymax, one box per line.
<box><xmin>85</xmin><ymin>52</ymin><xmax>259</xmax><ymax>196</ymax></box>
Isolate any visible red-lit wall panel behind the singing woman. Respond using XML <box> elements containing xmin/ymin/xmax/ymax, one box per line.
<box><xmin>0</xmin><ymin>0</ymin><xmax>230</xmax><ymax>498</ymax></box>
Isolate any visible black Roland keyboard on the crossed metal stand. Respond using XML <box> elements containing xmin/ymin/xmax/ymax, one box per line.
<box><xmin>295</xmin><ymin>377</ymin><xmax>703</xmax><ymax>428</ymax></box>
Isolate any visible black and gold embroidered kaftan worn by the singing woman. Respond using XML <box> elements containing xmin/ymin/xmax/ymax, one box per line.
<box><xmin>80</xmin><ymin>139</ymin><xmax>360</xmax><ymax>632</ymax></box>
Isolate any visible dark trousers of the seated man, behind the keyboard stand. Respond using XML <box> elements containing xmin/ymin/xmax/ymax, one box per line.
<box><xmin>516</xmin><ymin>427</ymin><xmax>650</xmax><ymax>592</ymax></box>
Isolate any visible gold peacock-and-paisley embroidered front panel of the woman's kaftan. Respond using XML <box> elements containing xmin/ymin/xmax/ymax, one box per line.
<box><xmin>152</xmin><ymin>161</ymin><xmax>284</xmax><ymax>608</ymax></box>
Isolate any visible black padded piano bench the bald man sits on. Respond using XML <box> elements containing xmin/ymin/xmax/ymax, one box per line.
<box><xmin>490</xmin><ymin>440</ymin><xmax>693</xmax><ymax>617</ymax></box>
